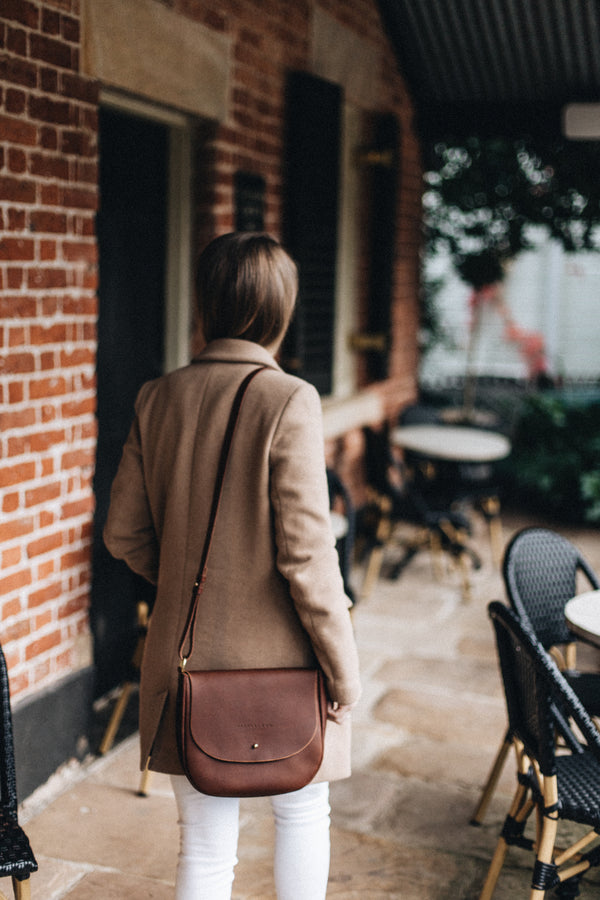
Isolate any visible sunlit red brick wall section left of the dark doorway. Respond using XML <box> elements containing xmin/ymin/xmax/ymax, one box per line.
<box><xmin>0</xmin><ymin>0</ymin><xmax>97</xmax><ymax>695</ymax></box>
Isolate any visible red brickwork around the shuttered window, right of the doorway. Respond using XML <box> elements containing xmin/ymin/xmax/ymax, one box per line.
<box><xmin>188</xmin><ymin>0</ymin><xmax>422</xmax><ymax>503</ymax></box>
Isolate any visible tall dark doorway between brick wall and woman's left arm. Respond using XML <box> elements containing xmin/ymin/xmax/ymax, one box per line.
<box><xmin>91</xmin><ymin>109</ymin><xmax>169</xmax><ymax>697</ymax></box>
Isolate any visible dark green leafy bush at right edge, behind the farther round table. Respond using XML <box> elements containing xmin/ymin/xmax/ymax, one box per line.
<box><xmin>505</xmin><ymin>392</ymin><xmax>600</xmax><ymax>523</ymax></box>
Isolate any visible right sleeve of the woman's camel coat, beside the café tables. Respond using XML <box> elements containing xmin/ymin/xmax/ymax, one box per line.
<box><xmin>270</xmin><ymin>383</ymin><xmax>360</xmax><ymax>704</ymax></box>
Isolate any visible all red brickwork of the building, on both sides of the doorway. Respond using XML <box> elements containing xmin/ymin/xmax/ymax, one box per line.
<box><xmin>0</xmin><ymin>0</ymin><xmax>420</xmax><ymax>696</ymax></box>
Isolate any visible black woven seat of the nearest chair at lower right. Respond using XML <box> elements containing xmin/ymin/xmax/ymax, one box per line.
<box><xmin>556</xmin><ymin>750</ymin><xmax>600</xmax><ymax>828</ymax></box>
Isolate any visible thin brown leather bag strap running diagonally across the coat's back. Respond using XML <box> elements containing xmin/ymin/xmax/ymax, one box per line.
<box><xmin>179</xmin><ymin>366</ymin><xmax>266</xmax><ymax>671</ymax></box>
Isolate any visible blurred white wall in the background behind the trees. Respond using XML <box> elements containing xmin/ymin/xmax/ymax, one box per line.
<box><xmin>421</xmin><ymin>233</ymin><xmax>600</xmax><ymax>384</ymax></box>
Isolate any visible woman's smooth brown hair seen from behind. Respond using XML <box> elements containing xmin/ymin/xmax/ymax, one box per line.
<box><xmin>196</xmin><ymin>231</ymin><xmax>298</xmax><ymax>347</ymax></box>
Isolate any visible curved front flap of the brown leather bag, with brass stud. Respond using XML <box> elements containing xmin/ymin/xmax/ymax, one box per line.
<box><xmin>184</xmin><ymin>669</ymin><xmax>326</xmax><ymax>763</ymax></box>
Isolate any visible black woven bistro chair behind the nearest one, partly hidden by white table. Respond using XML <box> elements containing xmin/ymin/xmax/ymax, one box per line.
<box><xmin>471</xmin><ymin>528</ymin><xmax>600</xmax><ymax>825</ymax></box>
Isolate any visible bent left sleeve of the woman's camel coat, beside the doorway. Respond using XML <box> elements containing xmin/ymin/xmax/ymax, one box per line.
<box><xmin>104</xmin><ymin>386</ymin><xmax>159</xmax><ymax>584</ymax></box>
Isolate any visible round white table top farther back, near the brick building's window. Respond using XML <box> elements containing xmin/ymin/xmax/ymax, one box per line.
<box><xmin>390</xmin><ymin>425</ymin><xmax>511</xmax><ymax>462</ymax></box>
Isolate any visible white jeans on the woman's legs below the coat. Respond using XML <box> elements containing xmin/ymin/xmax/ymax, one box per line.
<box><xmin>171</xmin><ymin>775</ymin><xmax>330</xmax><ymax>900</ymax></box>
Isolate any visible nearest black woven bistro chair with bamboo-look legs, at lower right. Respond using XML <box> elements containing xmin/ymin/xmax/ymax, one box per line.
<box><xmin>479</xmin><ymin>602</ymin><xmax>600</xmax><ymax>900</ymax></box>
